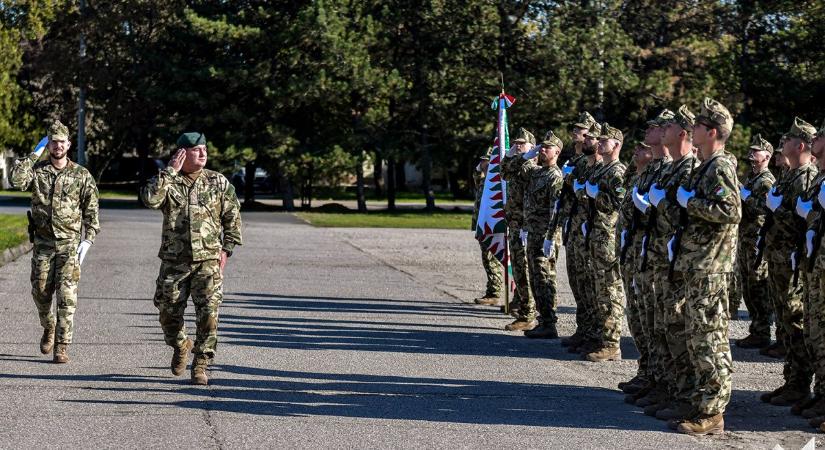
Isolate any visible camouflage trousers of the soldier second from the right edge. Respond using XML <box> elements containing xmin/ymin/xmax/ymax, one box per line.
<box><xmin>768</xmin><ymin>261</ymin><xmax>813</xmax><ymax>389</ymax></box>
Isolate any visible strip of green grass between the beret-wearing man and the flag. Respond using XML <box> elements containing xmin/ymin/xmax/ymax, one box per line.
<box><xmin>295</xmin><ymin>212</ymin><xmax>472</xmax><ymax>230</ymax></box>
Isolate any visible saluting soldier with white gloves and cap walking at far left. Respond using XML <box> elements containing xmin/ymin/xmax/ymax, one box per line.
<box><xmin>11</xmin><ymin>121</ymin><xmax>100</xmax><ymax>364</ymax></box>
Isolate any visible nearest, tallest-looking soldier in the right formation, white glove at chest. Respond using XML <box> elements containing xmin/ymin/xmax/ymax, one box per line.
<box><xmin>668</xmin><ymin>98</ymin><xmax>742</xmax><ymax>435</ymax></box>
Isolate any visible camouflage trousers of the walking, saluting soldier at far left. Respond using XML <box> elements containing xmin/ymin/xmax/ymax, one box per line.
<box><xmin>31</xmin><ymin>239</ymin><xmax>80</xmax><ymax>344</ymax></box>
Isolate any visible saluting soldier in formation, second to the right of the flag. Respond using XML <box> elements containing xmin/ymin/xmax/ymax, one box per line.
<box><xmin>508</xmin><ymin>131</ymin><xmax>562</xmax><ymax>339</ymax></box>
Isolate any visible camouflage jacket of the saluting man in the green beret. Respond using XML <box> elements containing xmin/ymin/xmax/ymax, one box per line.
<box><xmin>140</xmin><ymin>167</ymin><xmax>242</xmax><ymax>261</ymax></box>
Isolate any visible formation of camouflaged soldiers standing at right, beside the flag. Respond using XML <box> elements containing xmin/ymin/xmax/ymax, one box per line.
<box><xmin>474</xmin><ymin>99</ymin><xmax>825</xmax><ymax>434</ymax></box>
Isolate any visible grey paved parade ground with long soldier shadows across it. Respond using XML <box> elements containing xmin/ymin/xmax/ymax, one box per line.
<box><xmin>0</xmin><ymin>207</ymin><xmax>821</xmax><ymax>449</ymax></box>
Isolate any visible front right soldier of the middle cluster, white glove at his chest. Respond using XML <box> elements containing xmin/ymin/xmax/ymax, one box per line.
<box><xmin>582</xmin><ymin>122</ymin><xmax>627</xmax><ymax>362</ymax></box>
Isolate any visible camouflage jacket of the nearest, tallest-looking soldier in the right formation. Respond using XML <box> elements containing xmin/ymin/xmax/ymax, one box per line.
<box><xmin>675</xmin><ymin>150</ymin><xmax>742</xmax><ymax>273</ymax></box>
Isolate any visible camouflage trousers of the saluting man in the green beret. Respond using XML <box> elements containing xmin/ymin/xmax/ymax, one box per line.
<box><xmin>154</xmin><ymin>260</ymin><xmax>223</xmax><ymax>358</ymax></box>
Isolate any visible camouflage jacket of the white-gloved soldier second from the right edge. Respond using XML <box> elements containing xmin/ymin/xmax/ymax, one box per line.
<box><xmin>765</xmin><ymin>163</ymin><xmax>818</xmax><ymax>264</ymax></box>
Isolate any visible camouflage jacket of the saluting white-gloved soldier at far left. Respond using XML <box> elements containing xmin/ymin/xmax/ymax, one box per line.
<box><xmin>11</xmin><ymin>155</ymin><xmax>100</xmax><ymax>246</ymax></box>
